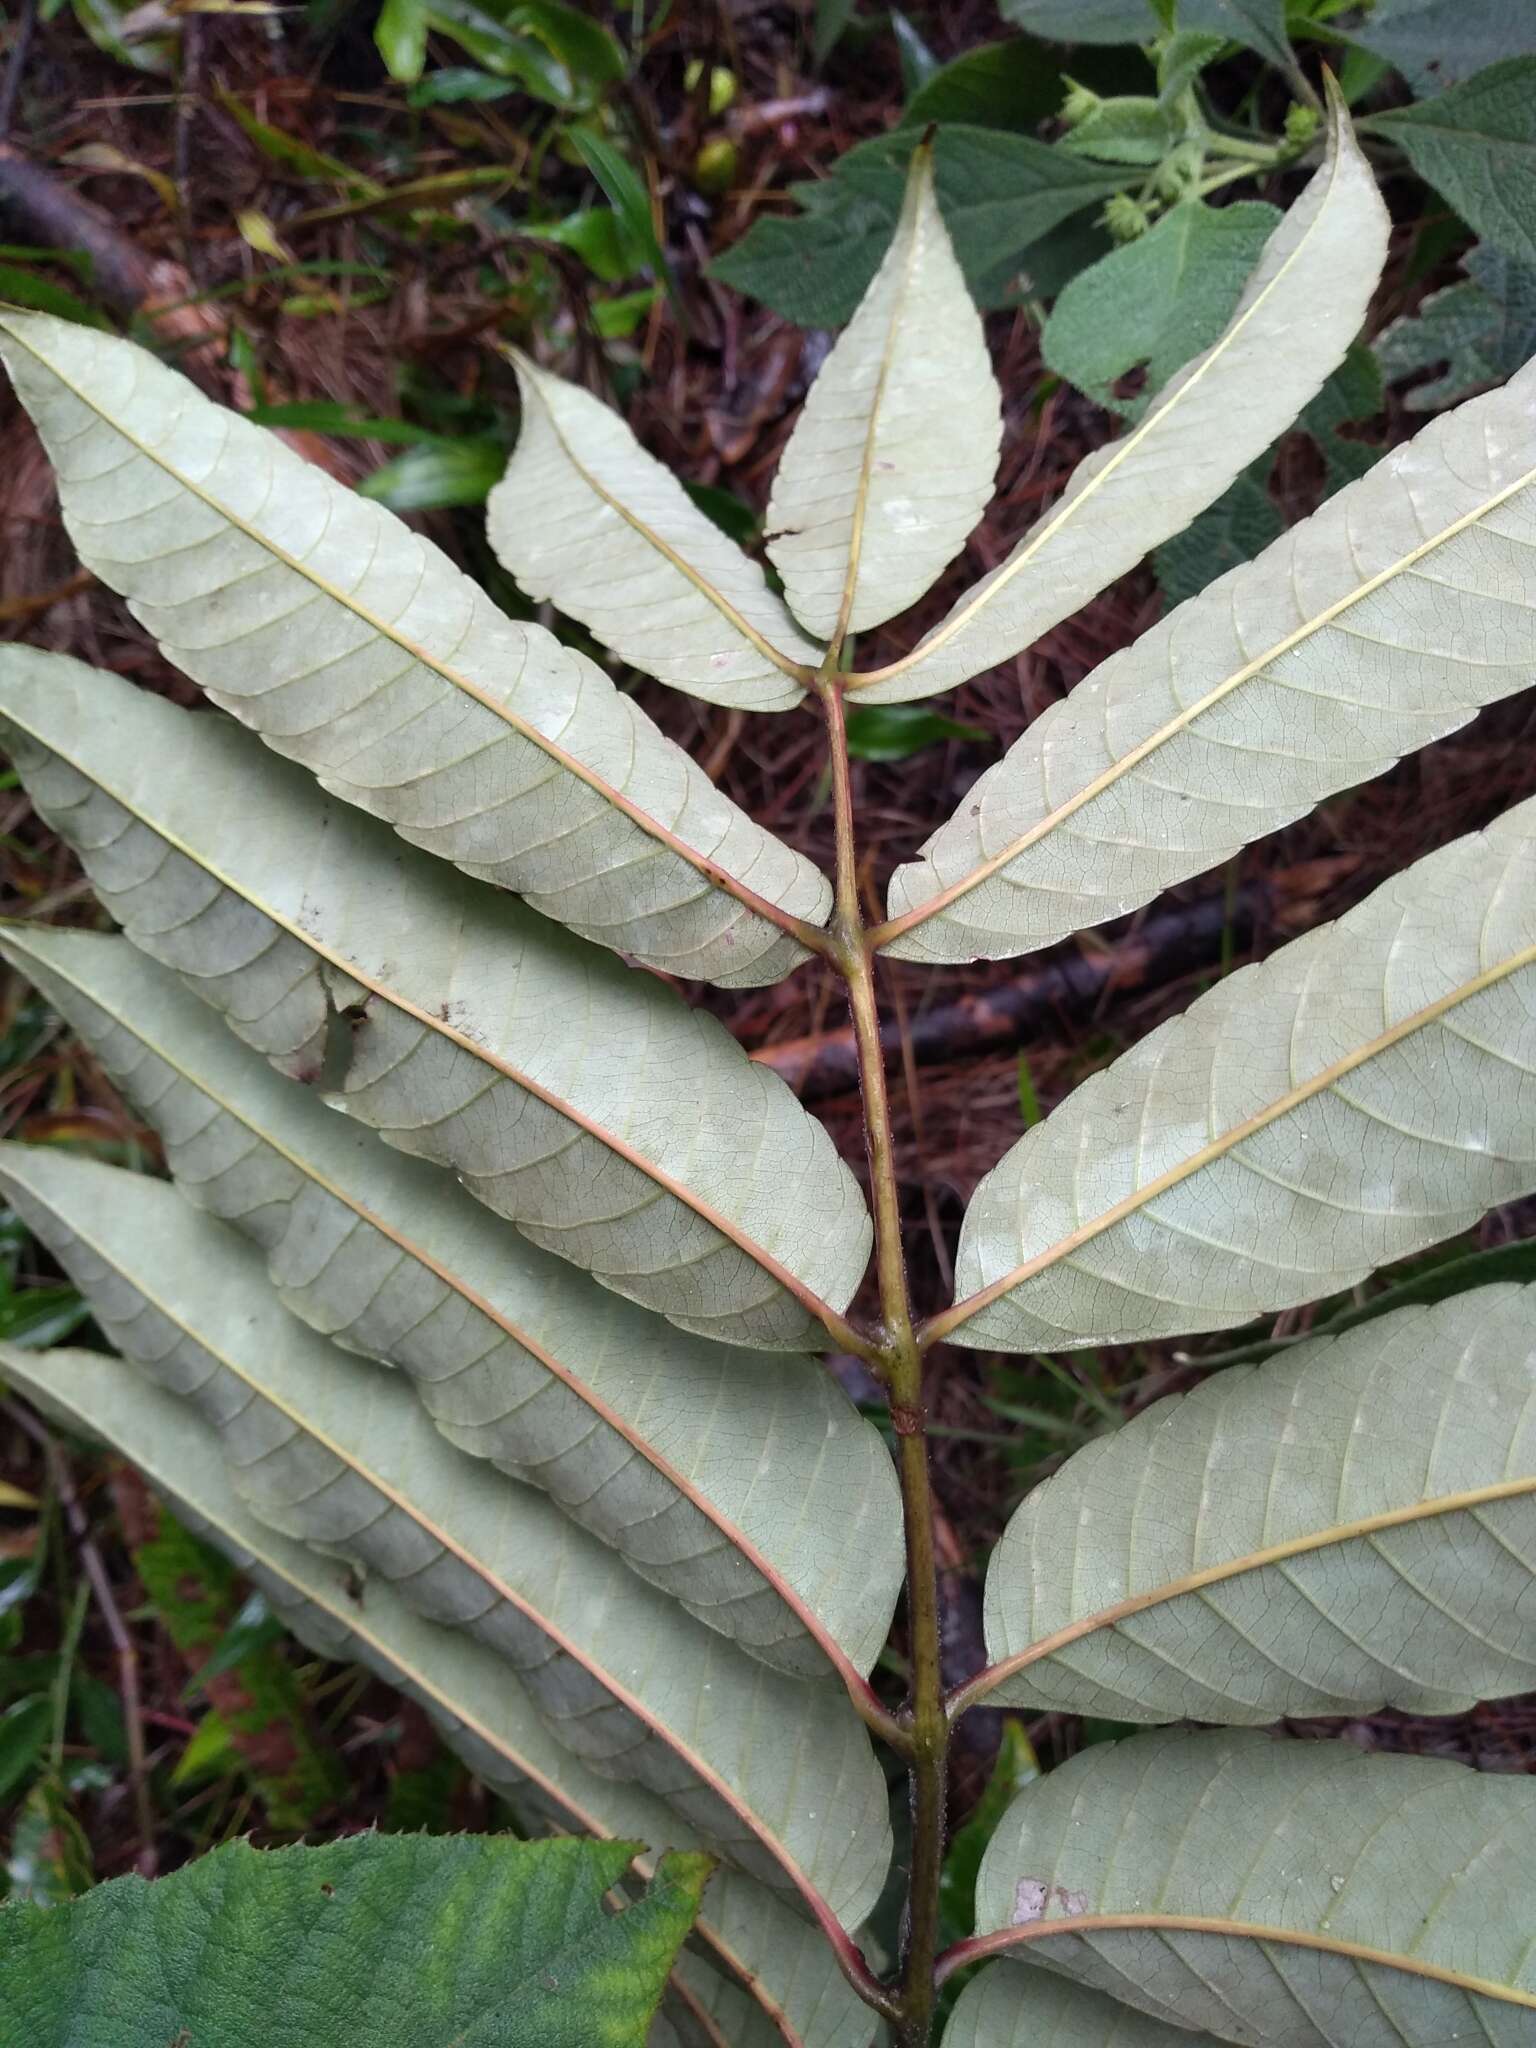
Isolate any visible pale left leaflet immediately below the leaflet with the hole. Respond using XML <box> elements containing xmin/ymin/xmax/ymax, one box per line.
<box><xmin>0</xmin><ymin>926</ymin><xmax>903</xmax><ymax>1675</ymax></box>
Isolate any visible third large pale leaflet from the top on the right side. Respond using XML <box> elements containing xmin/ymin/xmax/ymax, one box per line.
<box><xmin>987</xmin><ymin>1286</ymin><xmax>1536</xmax><ymax>1724</ymax></box>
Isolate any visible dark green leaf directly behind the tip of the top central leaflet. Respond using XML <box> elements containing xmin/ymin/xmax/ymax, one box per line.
<box><xmin>713</xmin><ymin>125</ymin><xmax>1122</xmax><ymax>328</ymax></box>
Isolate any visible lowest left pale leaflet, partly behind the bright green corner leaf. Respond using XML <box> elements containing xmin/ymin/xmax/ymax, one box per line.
<box><xmin>0</xmin><ymin>1346</ymin><xmax>884</xmax><ymax>2048</ymax></box>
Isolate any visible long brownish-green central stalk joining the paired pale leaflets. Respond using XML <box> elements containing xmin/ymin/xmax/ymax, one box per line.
<box><xmin>817</xmin><ymin>672</ymin><xmax>948</xmax><ymax>2048</ymax></box>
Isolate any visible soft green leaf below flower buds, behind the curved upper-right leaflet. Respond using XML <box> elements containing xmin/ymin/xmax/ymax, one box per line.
<box><xmin>1040</xmin><ymin>199</ymin><xmax>1280</xmax><ymax>414</ymax></box>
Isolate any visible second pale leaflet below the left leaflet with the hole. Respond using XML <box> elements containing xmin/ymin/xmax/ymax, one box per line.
<box><xmin>0</xmin><ymin>1171</ymin><xmax>889</xmax><ymax>1925</ymax></box>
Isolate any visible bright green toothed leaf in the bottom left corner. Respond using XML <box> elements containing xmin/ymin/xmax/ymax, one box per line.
<box><xmin>0</xmin><ymin>1835</ymin><xmax>709</xmax><ymax>2048</ymax></box>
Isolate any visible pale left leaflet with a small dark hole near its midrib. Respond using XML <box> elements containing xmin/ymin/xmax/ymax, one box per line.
<box><xmin>0</xmin><ymin>647</ymin><xmax>870</xmax><ymax>1348</ymax></box>
